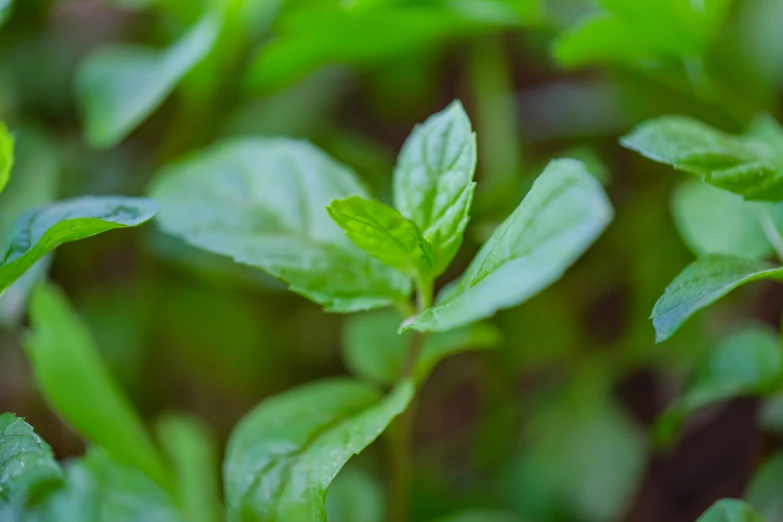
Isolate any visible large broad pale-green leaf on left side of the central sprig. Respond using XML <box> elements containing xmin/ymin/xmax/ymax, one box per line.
<box><xmin>151</xmin><ymin>139</ymin><xmax>411</xmax><ymax>312</ymax></box>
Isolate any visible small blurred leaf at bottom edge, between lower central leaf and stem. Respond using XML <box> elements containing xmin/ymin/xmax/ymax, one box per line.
<box><xmin>326</xmin><ymin>465</ymin><xmax>386</xmax><ymax>522</ymax></box>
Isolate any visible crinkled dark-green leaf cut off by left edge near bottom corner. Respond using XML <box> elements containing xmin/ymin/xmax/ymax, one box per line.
<box><xmin>0</xmin><ymin>413</ymin><xmax>63</xmax><ymax>506</ymax></box>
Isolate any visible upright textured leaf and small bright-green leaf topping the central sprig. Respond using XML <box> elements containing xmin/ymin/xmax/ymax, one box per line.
<box><xmin>327</xmin><ymin>101</ymin><xmax>477</xmax><ymax>281</ymax></box>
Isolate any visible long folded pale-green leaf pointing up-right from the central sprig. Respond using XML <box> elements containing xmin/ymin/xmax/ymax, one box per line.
<box><xmin>405</xmin><ymin>159</ymin><xmax>613</xmax><ymax>331</ymax></box>
